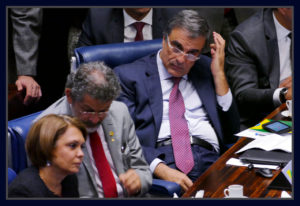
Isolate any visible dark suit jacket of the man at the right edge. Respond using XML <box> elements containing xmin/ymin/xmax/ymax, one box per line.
<box><xmin>226</xmin><ymin>9</ymin><xmax>280</xmax><ymax>127</ymax></box>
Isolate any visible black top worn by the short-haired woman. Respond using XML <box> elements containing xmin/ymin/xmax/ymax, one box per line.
<box><xmin>8</xmin><ymin>167</ymin><xmax>79</xmax><ymax>198</ymax></box>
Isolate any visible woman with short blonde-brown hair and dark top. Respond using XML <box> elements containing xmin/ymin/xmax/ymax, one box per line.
<box><xmin>8</xmin><ymin>114</ymin><xmax>87</xmax><ymax>197</ymax></box>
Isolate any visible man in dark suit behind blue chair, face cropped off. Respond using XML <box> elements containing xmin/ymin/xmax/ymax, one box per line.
<box><xmin>77</xmin><ymin>8</ymin><xmax>181</xmax><ymax>47</ymax></box>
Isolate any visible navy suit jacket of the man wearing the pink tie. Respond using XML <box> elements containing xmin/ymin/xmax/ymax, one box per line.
<box><xmin>114</xmin><ymin>53</ymin><xmax>239</xmax><ymax>163</ymax></box>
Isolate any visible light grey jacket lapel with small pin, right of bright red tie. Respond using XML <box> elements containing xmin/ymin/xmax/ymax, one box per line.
<box><xmin>102</xmin><ymin>115</ymin><xmax>124</xmax><ymax>175</ymax></box>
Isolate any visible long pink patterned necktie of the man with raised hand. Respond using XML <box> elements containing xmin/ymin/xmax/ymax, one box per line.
<box><xmin>169</xmin><ymin>77</ymin><xmax>194</xmax><ymax>174</ymax></box>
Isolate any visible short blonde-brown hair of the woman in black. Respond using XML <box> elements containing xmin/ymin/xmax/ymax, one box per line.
<box><xmin>25</xmin><ymin>114</ymin><xmax>87</xmax><ymax>168</ymax></box>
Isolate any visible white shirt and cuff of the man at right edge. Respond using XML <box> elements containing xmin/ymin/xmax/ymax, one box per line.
<box><xmin>273</xmin><ymin>12</ymin><xmax>292</xmax><ymax>106</ymax></box>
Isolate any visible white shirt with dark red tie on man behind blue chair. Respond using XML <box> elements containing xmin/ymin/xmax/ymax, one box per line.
<box><xmin>123</xmin><ymin>9</ymin><xmax>153</xmax><ymax>42</ymax></box>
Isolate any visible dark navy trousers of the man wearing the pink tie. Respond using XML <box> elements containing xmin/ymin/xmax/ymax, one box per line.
<box><xmin>158</xmin><ymin>144</ymin><xmax>219</xmax><ymax>182</ymax></box>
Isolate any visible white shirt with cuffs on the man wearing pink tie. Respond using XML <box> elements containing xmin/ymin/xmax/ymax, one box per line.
<box><xmin>150</xmin><ymin>51</ymin><xmax>232</xmax><ymax>172</ymax></box>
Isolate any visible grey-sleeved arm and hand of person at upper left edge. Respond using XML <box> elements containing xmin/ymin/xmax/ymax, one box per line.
<box><xmin>10</xmin><ymin>8</ymin><xmax>43</xmax><ymax>105</ymax></box>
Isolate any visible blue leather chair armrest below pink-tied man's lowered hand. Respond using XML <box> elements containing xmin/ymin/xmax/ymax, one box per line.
<box><xmin>149</xmin><ymin>179</ymin><xmax>181</xmax><ymax>197</ymax></box>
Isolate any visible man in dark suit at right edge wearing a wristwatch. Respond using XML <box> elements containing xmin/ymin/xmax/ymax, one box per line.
<box><xmin>226</xmin><ymin>8</ymin><xmax>292</xmax><ymax>129</ymax></box>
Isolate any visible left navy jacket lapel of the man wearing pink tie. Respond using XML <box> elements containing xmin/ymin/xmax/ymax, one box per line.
<box><xmin>145</xmin><ymin>54</ymin><xmax>163</xmax><ymax>137</ymax></box>
